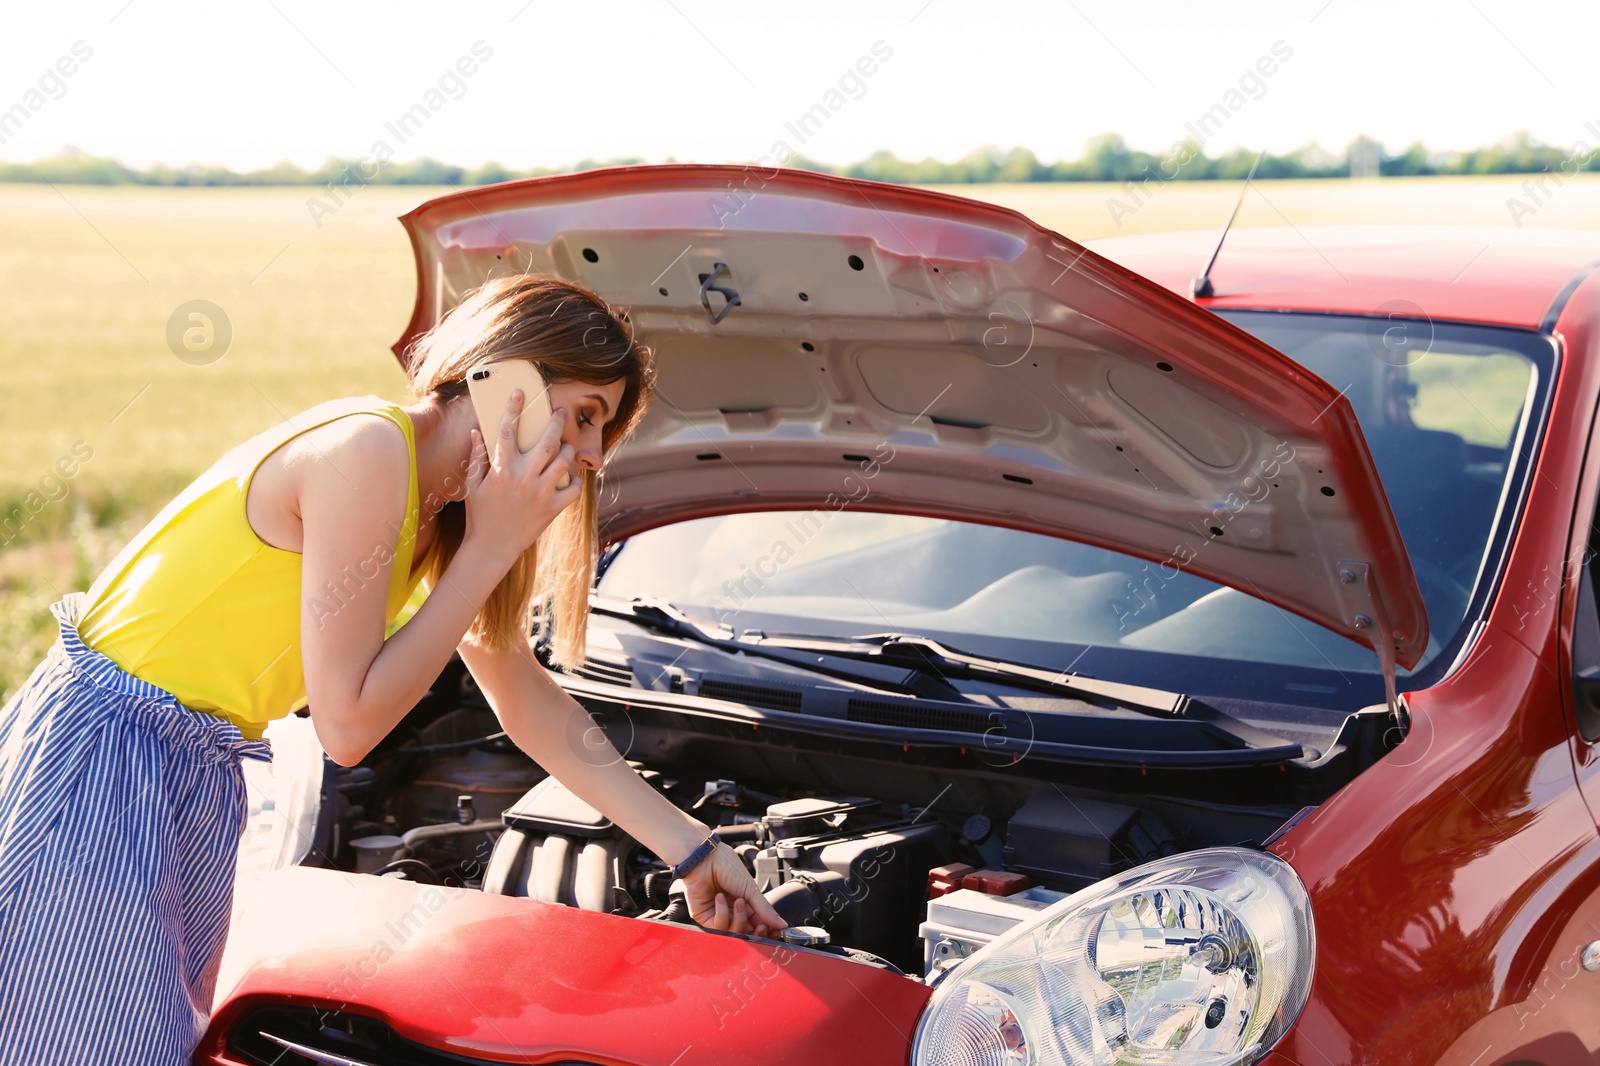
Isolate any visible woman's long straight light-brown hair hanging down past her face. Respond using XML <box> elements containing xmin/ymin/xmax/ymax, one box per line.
<box><xmin>406</xmin><ymin>274</ymin><xmax>656</xmax><ymax>669</ymax></box>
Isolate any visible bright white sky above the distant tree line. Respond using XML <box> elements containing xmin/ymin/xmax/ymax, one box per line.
<box><xmin>0</xmin><ymin>0</ymin><xmax>1600</xmax><ymax>170</ymax></box>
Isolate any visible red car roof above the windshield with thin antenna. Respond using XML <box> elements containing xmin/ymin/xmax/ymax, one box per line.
<box><xmin>1086</xmin><ymin>226</ymin><xmax>1600</xmax><ymax>331</ymax></box>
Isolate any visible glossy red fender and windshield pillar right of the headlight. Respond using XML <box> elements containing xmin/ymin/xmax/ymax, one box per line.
<box><xmin>1274</xmin><ymin>277</ymin><xmax>1600</xmax><ymax>1066</ymax></box>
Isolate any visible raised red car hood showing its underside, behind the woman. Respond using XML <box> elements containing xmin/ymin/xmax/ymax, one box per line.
<box><xmin>395</xmin><ymin>165</ymin><xmax>1427</xmax><ymax>666</ymax></box>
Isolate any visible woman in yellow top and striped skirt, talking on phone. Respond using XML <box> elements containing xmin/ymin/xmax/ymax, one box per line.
<box><xmin>0</xmin><ymin>275</ymin><xmax>782</xmax><ymax>1066</ymax></box>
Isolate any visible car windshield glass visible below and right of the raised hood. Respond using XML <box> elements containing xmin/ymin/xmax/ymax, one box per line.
<box><xmin>597</xmin><ymin>312</ymin><xmax>1555</xmax><ymax>709</ymax></box>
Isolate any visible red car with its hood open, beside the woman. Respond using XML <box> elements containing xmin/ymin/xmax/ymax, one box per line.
<box><xmin>197</xmin><ymin>166</ymin><xmax>1600</xmax><ymax>1066</ymax></box>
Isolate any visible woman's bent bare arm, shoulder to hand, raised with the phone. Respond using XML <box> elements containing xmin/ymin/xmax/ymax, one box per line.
<box><xmin>293</xmin><ymin>390</ymin><xmax>582</xmax><ymax>767</ymax></box>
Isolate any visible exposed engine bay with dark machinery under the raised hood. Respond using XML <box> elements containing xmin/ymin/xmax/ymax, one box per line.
<box><xmin>284</xmin><ymin>663</ymin><xmax>1337</xmax><ymax>976</ymax></box>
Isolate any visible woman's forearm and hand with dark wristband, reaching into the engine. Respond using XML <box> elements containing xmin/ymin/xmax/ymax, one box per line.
<box><xmin>461</xmin><ymin>633</ymin><xmax>784</xmax><ymax>936</ymax></box>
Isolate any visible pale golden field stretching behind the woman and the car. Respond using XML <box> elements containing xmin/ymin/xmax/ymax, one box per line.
<box><xmin>0</xmin><ymin>178</ymin><xmax>1600</xmax><ymax>698</ymax></box>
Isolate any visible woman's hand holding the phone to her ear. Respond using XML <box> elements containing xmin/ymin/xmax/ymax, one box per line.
<box><xmin>462</xmin><ymin>389</ymin><xmax>582</xmax><ymax>570</ymax></box>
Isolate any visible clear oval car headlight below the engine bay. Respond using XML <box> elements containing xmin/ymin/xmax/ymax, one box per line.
<box><xmin>912</xmin><ymin>848</ymin><xmax>1315</xmax><ymax>1066</ymax></box>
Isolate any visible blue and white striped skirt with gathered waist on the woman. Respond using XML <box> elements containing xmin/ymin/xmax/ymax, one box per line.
<box><xmin>0</xmin><ymin>594</ymin><xmax>272</xmax><ymax>1066</ymax></box>
